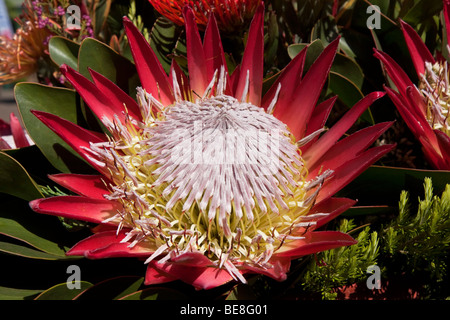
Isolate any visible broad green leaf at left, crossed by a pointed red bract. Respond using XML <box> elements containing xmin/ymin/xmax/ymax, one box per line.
<box><xmin>14</xmin><ymin>83</ymin><xmax>92</xmax><ymax>173</ymax></box>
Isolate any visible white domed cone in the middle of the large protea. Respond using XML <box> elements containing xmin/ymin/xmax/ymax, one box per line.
<box><xmin>145</xmin><ymin>96</ymin><xmax>302</xmax><ymax>236</ymax></box>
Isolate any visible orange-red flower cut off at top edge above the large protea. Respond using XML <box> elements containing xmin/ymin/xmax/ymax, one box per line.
<box><xmin>149</xmin><ymin>0</ymin><xmax>261</xmax><ymax>32</ymax></box>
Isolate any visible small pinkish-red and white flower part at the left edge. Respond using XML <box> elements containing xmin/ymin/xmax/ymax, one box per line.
<box><xmin>0</xmin><ymin>113</ymin><xmax>33</xmax><ymax>150</ymax></box>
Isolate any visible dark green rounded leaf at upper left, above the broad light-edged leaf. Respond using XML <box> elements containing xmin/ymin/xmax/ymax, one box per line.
<box><xmin>78</xmin><ymin>38</ymin><xmax>139</xmax><ymax>97</ymax></box>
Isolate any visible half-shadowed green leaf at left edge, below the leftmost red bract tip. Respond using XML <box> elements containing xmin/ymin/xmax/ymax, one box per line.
<box><xmin>0</xmin><ymin>195</ymin><xmax>73</xmax><ymax>259</ymax></box>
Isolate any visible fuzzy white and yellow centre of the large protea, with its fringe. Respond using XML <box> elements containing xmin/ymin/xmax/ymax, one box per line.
<box><xmin>89</xmin><ymin>85</ymin><xmax>326</xmax><ymax>282</ymax></box>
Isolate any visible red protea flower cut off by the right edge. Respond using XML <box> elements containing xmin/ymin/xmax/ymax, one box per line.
<box><xmin>375</xmin><ymin>0</ymin><xmax>450</xmax><ymax>170</ymax></box>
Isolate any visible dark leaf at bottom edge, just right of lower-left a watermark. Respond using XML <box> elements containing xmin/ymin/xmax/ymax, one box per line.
<box><xmin>77</xmin><ymin>276</ymin><xmax>144</xmax><ymax>300</ymax></box>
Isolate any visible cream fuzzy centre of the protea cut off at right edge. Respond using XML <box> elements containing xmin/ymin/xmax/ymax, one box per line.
<box><xmin>419</xmin><ymin>61</ymin><xmax>450</xmax><ymax>136</ymax></box>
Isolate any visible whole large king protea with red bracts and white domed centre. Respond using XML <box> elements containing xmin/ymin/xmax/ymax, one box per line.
<box><xmin>31</xmin><ymin>5</ymin><xmax>392</xmax><ymax>289</ymax></box>
